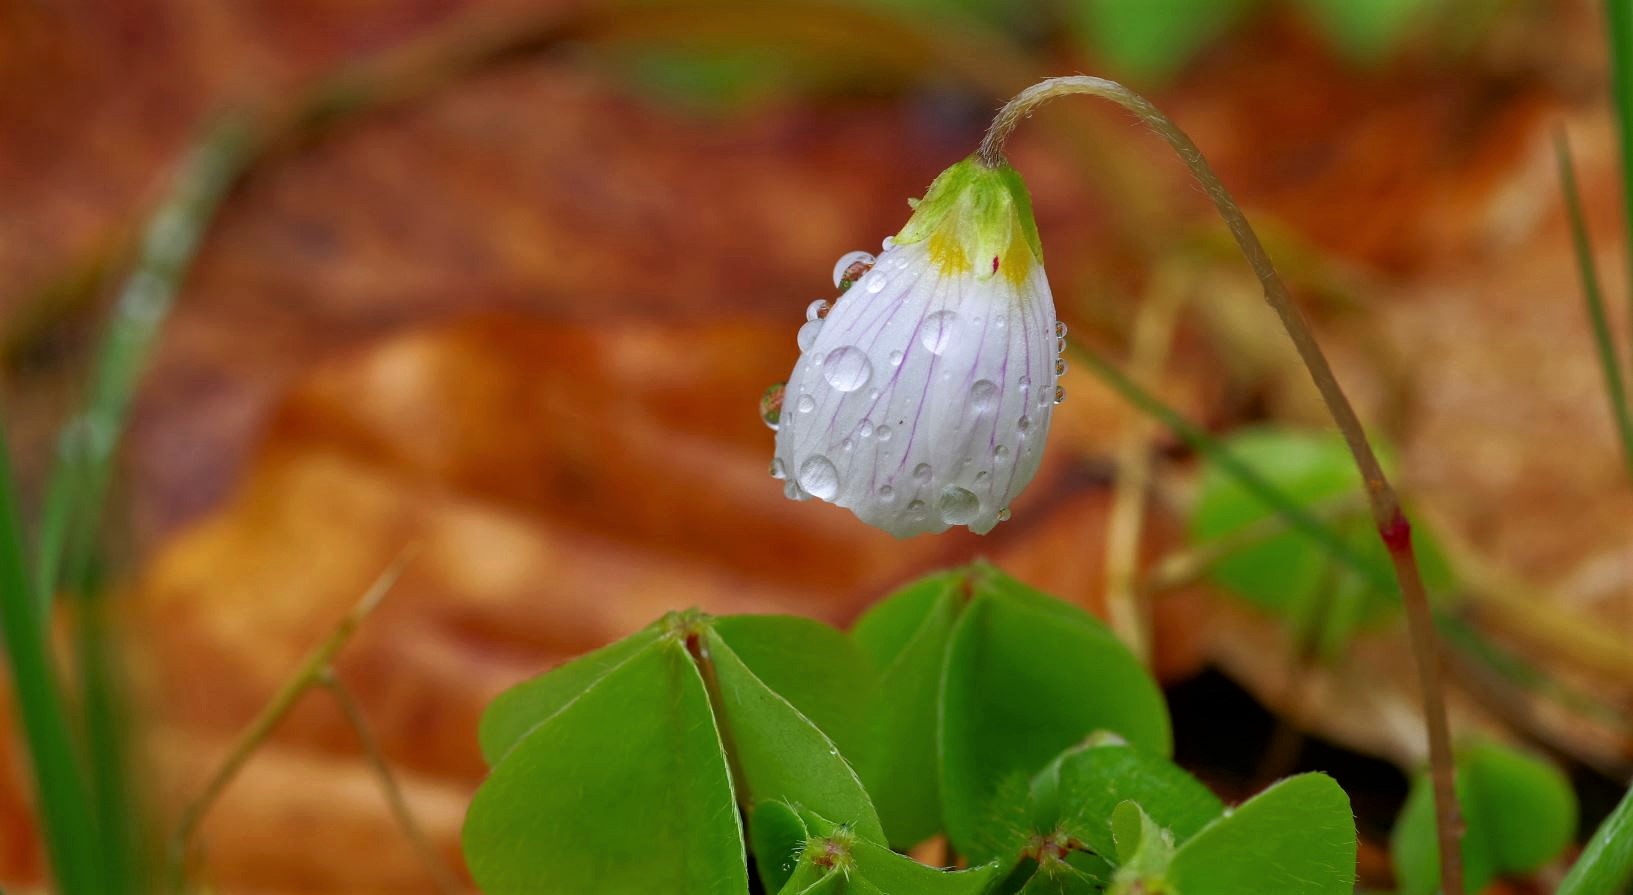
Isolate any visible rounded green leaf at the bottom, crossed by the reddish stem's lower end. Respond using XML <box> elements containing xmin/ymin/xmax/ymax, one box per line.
<box><xmin>1390</xmin><ymin>743</ymin><xmax>1576</xmax><ymax>895</ymax></box>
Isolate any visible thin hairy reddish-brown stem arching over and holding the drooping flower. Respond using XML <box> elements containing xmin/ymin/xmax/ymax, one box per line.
<box><xmin>978</xmin><ymin>75</ymin><xmax>1463</xmax><ymax>895</ymax></box>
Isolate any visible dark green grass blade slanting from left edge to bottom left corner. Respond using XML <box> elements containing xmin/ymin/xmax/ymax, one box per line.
<box><xmin>0</xmin><ymin>421</ymin><xmax>106</xmax><ymax>893</ymax></box>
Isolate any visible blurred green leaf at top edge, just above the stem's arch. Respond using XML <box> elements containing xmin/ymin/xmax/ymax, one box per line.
<box><xmin>1066</xmin><ymin>0</ymin><xmax>1254</xmax><ymax>80</ymax></box>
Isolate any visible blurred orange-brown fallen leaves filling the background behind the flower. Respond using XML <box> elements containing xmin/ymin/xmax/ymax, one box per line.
<box><xmin>0</xmin><ymin>0</ymin><xmax>1633</xmax><ymax>892</ymax></box>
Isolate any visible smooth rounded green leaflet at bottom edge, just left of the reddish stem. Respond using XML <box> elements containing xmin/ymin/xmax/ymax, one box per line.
<box><xmin>1168</xmin><ymin>774</ymin><xmax>1355</xmax><ymax>895</ymax></box>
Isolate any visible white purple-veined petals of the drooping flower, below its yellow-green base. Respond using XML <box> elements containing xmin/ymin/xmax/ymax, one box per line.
<box><xmin>777</xmin><ymin>242</ymin><xmax>1057</xmax><ymax>537</ymax></box>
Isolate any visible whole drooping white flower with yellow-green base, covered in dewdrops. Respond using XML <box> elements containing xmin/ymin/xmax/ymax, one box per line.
<box><xmin>763</xmin><ymin>158</ymin><xmax>1065</xmax><ymax>537</ymax></box>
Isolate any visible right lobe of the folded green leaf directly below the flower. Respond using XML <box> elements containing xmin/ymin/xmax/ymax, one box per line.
<box><xmin>939</xmin><ymin>567</ymin><xmax>1171</xmax><ymax>861</ymax></box>
